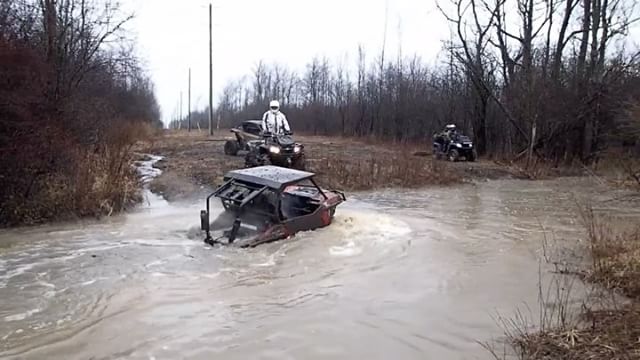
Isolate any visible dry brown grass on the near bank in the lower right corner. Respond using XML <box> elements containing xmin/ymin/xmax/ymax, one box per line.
<box><xmin>485</xmin><ymin>207</ymin><xmax>640</xmax><ymax>360</ymax></box>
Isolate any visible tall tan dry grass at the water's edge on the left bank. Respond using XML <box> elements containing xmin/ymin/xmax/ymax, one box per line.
<box><xmin>0</xmin><ymin>123</ymin><xmax>153</xmax><ymax>226</ymax></box>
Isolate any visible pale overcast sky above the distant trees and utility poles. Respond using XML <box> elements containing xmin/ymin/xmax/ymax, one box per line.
<box><xmin>124</xmin><ymin>0</ymin><xmax>449</xmax><ymax>123</ymax></box>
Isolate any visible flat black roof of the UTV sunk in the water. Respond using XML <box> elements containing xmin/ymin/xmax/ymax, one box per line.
<box><xmin>225</xmin><ymin>165</ymin><xmax>315</xmax><ymax>190</ymax></box>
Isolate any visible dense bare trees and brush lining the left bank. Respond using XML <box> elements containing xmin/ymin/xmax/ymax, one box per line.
<box><xmin>0</xmin><ymin>0</ymin><xmax>161</xmax><ymax>226</ymax></box>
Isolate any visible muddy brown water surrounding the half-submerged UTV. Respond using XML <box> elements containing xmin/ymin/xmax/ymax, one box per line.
<box><xmin>0</xmin><ymin>159</ymin><xmax>639</xmax><ymax>359</ymax></box>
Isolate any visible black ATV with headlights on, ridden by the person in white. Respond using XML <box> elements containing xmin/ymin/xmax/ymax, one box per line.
<box><xmin>244</xmin><ymin>133</ymin><xmax>306</xmax><ymax>170</ymax></box>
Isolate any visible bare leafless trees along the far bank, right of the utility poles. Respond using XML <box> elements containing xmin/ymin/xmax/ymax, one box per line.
<box><xmin>174</xmin><ymin>0</ymin><xmax>640</xmax><ymax>163</ymax></box>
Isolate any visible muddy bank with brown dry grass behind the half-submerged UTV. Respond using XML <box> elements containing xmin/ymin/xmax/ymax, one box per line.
<box><xmin>139</xmin><ymin>130</ymin><xmax>527</xmax><ymax>201</ymax></box>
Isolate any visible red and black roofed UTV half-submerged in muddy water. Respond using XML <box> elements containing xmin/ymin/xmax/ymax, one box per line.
<box><xmin>200</xmin><ymin>166</ymin><xmax>346</xmax><ymax>247</ymax></box>
